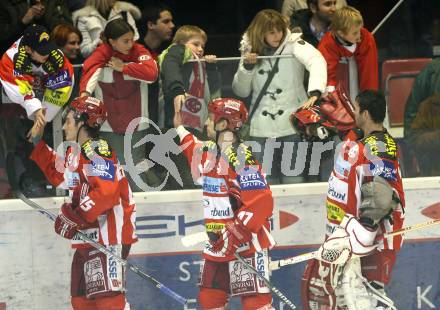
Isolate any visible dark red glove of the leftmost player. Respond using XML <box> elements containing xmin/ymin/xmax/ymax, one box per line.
<box><xmin>54</xmin><ymin>203</ymin><xmax>87</xmax><ymax>239</ymax></box>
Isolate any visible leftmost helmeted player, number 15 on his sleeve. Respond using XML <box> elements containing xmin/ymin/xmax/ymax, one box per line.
<box><xmin>31</xmin><ymin>96</ymin><xmax>137</xmax><ymax>310</ymax></box>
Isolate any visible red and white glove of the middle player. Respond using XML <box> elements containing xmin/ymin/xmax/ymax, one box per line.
<box><xmin>211</xmin><ymin>219</ymin><xmax>252</xmax><ymax>256</ymax></box>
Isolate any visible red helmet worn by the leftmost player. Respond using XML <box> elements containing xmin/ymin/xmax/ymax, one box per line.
<box><xmin>69</xmin><ymin>96</ymin><xmax>107</xmax><ymax>128</ymax></box>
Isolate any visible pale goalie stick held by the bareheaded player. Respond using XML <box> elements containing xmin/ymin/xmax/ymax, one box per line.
<box><xmin>269</xmin><ymin>219</ymin><xmax>440</xmax><ymax>270</ymax></box>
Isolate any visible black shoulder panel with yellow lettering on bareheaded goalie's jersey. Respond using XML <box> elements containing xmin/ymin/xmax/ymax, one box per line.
<box><xmin>360</xmin><ymin>131</ymin><xmax>397</xmax><ymax>160</ymax></box>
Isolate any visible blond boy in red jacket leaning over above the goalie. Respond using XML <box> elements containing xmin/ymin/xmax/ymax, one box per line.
<box><xmin>318</xmin><ymin>6</ymin><xmax>379</xmax><ymax>92</ymax></box>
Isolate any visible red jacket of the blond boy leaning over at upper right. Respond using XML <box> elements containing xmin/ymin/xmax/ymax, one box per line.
<box><xmin>318</xmin><ymin>28</ymin><xmax>379</xmax><ymax>91</ymax></box>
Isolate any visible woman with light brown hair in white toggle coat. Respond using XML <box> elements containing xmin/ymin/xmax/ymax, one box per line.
<box><xmin>232</xmin><ymin>10</ymin><xmax>327</xmax><ymax>184</ymax></box>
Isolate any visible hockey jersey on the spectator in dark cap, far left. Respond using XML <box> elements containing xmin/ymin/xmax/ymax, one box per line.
<box><xmin>0</xmin><ymin>38</ymin><xmax>74</xmax><ymax>121</ymax></box>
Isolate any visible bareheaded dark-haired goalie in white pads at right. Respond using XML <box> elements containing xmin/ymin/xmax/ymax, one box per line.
<box><xmin>301</xmin><ymin>90</ymin><xmax>405</xmax><ymax>310</ymax></box>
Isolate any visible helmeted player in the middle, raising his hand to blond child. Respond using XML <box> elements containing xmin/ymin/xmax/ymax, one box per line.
<box><xmin>174</xmin><ymin>98</ymin><xmax>275</xmax><ymax>310</ymax></box>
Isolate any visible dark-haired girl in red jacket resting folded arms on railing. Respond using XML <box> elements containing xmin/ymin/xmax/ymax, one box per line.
<box><xmin>80</xmin><ymin>19</ymin><xmax>158</xmax><ymax>134</ymax></box>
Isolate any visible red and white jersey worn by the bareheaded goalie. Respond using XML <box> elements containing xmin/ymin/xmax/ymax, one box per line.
<box><xmin>326</xmin><ymin>130</ymin><xmax>405</xmax><ymax>250</ymax></box>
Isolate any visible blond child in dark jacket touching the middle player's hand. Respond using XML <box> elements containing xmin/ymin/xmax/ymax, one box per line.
<box><xmin>159</xmin><ymin>25</ymin><xmax>221</xmax><ymax>130</ymax></box>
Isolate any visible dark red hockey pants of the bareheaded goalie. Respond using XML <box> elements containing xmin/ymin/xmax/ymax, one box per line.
<box><xmin>361</xmin><ymin>250</ymin><xmax>396</xmax><ymax>285</ymax></box>
